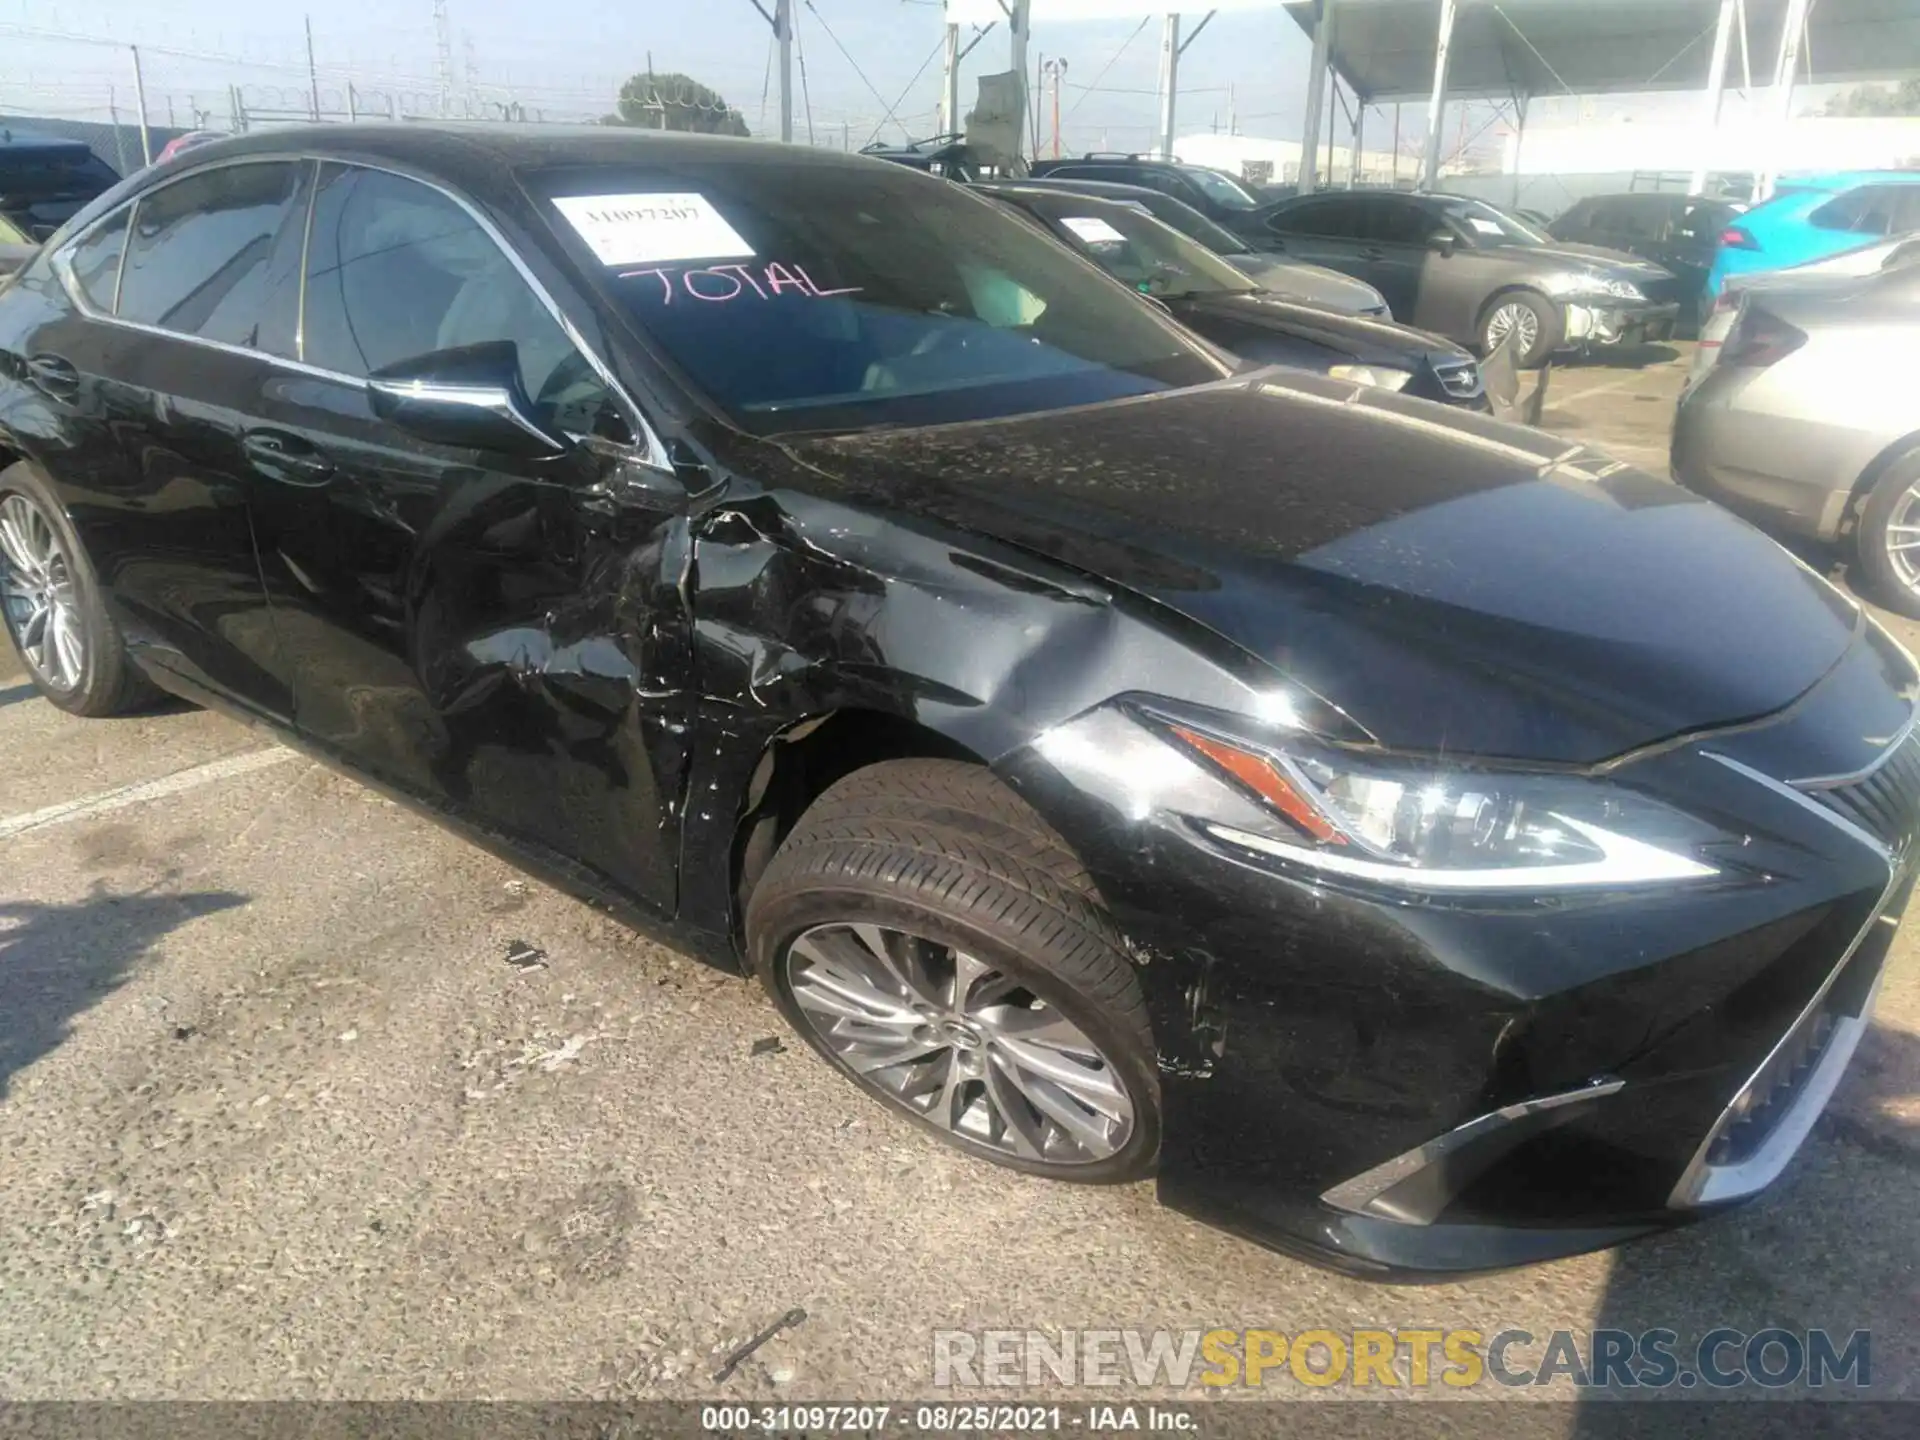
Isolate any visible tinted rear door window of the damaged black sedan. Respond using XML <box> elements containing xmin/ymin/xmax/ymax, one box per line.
<box><xmin>117</xmin><ymin>161</ymin><xmax>300</xmax><ymax>346</ymax></box>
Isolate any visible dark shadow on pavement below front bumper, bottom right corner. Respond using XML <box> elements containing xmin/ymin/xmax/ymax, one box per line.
<box><xmin>1569</xmin><ymin>1025</ymin><xmax>1920</xmax><ymax>1440</ymax></box>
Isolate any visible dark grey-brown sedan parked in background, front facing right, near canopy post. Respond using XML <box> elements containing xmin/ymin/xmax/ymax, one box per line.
<box><xmin>1261</xmin><ymin>190</ymin><xmax>1682</xmax><ymax>365</ymax></box>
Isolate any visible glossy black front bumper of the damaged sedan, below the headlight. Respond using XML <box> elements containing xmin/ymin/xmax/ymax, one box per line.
<box><xmin>1010</xmin><ymin>637</ymin><xmax>1920</xmax><ymax>1281</ymax></box>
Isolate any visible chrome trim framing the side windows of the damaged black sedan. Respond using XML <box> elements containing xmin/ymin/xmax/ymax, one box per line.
<box><xmin>52</xmin><ymin>150</ymin><xmax>674</xmax><ymax>474</ymax></box>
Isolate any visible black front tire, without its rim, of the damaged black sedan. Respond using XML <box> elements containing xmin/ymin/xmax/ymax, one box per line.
<box><xmin>747</xmin><ymin>760</ymin><xmax>1160</xmax><ymax>1185</ymax></box>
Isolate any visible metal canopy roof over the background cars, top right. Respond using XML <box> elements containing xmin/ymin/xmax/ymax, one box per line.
<box><xmin>1288</xmin><ymin>0</ymin><xmax>1920</xmax><ymax>104</ymax></box>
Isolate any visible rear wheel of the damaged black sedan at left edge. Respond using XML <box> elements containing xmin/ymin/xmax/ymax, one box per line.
<box><xmin>0</xmin><ymin>465</ymin><xmax>156</xmax><ymax>716</ymax></box>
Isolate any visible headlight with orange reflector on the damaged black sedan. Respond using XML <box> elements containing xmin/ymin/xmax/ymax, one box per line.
<box><xmin>1039</xmin><ymin>701</ymin><xmax>1734</xmax><ymax>891</ymax></box>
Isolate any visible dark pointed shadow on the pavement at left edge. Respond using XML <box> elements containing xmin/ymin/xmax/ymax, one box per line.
<box><xmin>0</xmin><ymin>889</ymin><xmax>248</xmax><ymax>1100</ymax></box>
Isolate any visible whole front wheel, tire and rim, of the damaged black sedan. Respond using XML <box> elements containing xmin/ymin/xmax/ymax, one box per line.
<box><xmin>747</xmin><ymin>760</ymin><xmax>1160</xmax><ymax>1183</ymax></box>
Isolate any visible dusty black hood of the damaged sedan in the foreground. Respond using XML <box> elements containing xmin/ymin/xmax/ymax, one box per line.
<box><xmin>783</xmin><ymin>371</ymin><xmax>1862</xmax><ymax>762</ymax></box>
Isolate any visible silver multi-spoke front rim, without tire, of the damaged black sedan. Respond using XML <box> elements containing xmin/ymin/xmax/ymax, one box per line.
<box><xmin>785</xmin><ymin>925</ymin><xmax>1135</xmax><ymax>1167</ymax></box>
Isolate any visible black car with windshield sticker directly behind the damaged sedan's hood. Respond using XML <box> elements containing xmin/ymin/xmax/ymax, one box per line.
<box><xmin>979</xmin><ymin>184</ymin><xmax>1488</xmax><ymax>409</ymax></box>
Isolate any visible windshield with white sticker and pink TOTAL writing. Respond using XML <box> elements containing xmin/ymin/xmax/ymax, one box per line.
<box><xmin>528</xmin><ymin>160</ymin><xmax>1225</xmax><ymax>434</ymax></box>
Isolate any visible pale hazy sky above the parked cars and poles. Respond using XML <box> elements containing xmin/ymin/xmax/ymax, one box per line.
<box><xmin>0</xmin><ymin>0</ymin><xmax>1889</xmax><ymax>154</ymax></box>
